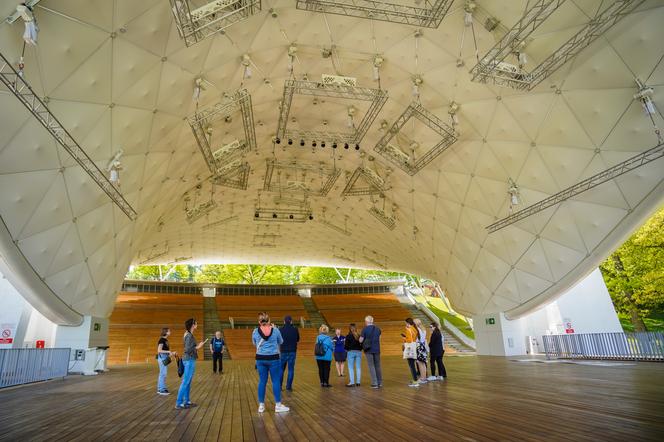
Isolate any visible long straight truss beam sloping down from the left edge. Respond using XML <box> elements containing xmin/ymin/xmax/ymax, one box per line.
<box><xmin>0</xmin><ymin>53</ymin><xmax>138</xmax><ymax>220</ymax></box>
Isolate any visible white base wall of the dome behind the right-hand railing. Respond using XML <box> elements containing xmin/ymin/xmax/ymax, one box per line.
<box><xmin>473</xmin><ymin>269</ymin><xmax>622</xmax><ymax>356</ymax></box>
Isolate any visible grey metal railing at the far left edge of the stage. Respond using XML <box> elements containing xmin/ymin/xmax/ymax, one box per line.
<box><xmin>0</xmin><ymin>348</ymin><xmax>71</xmax><ymax>388</ymax></box>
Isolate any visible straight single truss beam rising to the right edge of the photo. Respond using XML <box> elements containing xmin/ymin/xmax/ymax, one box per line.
<box><xmin>486</xmin><ymin>143</ymin><xmax>664</xmax><ymax>233</ymax></box>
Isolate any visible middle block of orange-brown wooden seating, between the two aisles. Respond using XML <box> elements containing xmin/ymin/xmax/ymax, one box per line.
<box><xmin>216</xmin><ymin>295</ymin><xmax>309</xmax><ymax>324</ymax></box>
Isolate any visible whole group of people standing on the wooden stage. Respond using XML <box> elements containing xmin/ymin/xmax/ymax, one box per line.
<box><xmin>156</xmin><ymin>312</ymin><xmax>447</xmax><ymax>413</ymax></box>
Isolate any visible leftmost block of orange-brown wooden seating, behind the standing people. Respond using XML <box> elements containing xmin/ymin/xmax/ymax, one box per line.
<box><xmin>108</xmin><ymin>292</ymin><xmax>204</xmax><ymax>364</ymax></box>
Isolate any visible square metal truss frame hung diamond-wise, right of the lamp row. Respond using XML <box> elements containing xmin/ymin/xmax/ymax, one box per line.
<box><xmin>374</xmin><ymin>102</ymin><xmax>457</xmax><ymax>175</ymax></box>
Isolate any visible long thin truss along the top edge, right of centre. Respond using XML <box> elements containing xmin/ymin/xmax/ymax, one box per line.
<box><xmin>295</xmin><ymin>0</ymin><xmax>453</xmax><ymax>28</ymax></box>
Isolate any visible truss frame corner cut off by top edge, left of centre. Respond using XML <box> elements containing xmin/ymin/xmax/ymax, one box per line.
<box><xmin>170</xmin><ymin>0</ymin><xmax>261</xmax><ymax>46</ymax></box>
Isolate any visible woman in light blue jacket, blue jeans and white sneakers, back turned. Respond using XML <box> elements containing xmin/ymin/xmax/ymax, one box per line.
<box><xmin>251</xmin><ymin>312</ymin><xmax>289</xmax><ymax>413</ymax></box>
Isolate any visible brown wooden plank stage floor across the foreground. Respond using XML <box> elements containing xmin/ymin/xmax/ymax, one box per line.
<box><xmin>0</xmin><ymin>356</ymin><xmax>664</xmax><ymax>442</ymax></box>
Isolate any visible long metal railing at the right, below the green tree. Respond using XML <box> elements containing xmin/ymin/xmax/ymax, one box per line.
<box><xmin>542</xmin><ymin>332</ymin><xmax>664</xmax><ymax>362</ymax></box>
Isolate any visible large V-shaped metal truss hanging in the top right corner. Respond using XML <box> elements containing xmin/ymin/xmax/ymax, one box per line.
<box><xmin>470</xmin><ymin>0</ymin><xmax>644</xmax><ymax>90</ymax></box>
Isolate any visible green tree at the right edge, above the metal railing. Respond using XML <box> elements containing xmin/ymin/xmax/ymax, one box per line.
<box><xmin>600</xmin><ymin>208</ymin><xmax>664</xmax><ymax>331</ymax></box>
